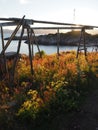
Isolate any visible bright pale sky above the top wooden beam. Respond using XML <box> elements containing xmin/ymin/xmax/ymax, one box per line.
<box><xmin>0</xmin><ymin>0</ymin><xmax>98</xmax><ymax>33</ymax></box>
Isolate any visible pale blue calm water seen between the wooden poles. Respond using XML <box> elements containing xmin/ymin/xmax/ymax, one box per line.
<box><xmin>0</xmin><ymin>34</ymin><xmax>96</xmax><ymax>55</ymax></box>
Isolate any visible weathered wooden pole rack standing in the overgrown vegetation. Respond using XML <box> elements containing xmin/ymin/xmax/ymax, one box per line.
<box><xmin>0</xmin><ymin>16</ymin><xmax>98</xmax><ymax>81</ymax></box>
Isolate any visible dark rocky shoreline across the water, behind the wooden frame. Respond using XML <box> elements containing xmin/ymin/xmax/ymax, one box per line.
<box><xmin>4</xmin><ymin>31</ymin><xmax>98</xmax><ymax>46</ymax></box>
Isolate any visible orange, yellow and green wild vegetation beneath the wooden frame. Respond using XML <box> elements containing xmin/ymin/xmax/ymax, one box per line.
<box><xmin>0</xmin><ymin>51</ymin><xmax>98</xmax><ymax>130</ymax></box>
